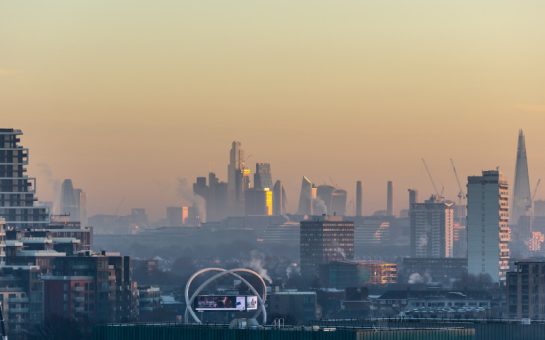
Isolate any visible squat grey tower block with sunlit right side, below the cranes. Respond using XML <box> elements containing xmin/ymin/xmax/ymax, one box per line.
<box><xmin>409</xmin><ymin>196</ymin><xmax>454</xmax><ymax>257</ymax></box>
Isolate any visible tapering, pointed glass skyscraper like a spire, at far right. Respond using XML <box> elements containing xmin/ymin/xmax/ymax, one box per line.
<box><xmin>511</xmin><ymin>130</ymin><xmax>532</xmax><ymax>224</ymax></box>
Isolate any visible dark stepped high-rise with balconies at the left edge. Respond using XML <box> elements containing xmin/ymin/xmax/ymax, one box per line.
<box><xmin>0</xmin><ymin>129</ymin><xmax>49</xmax><ymax>229</ymax></box>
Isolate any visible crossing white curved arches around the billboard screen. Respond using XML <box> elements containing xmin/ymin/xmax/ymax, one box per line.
<box><xmin>184</xmin><ymin>268</ymin><xmax>267</xmax><ymax>324</ymax></box>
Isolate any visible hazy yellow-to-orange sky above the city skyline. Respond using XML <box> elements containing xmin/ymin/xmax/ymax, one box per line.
<box><xmin>0</xmin><ymin>0</ymin><xmax>545</xmax><ymax>218</ymax></box>
